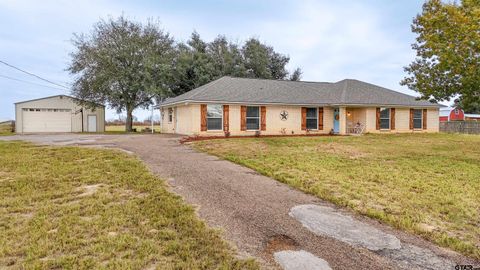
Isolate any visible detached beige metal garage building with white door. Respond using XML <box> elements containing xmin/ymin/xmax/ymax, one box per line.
<box><xmin>15</xmin><ymin>95</ymin><xmax>105</xmax><ymax>133</ymax></box>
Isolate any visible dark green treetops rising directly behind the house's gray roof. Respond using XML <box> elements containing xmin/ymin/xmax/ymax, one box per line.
<box><xmin>171</xmin><ymin>32</ymin><xmax>302</xmax><ymax>95</ymax></box>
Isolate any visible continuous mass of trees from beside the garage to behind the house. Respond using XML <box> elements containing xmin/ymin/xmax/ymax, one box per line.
<box><xmin>68</xmin><ymin>15</ymin><xmax>302</xmax><ymax>131</ymax></box>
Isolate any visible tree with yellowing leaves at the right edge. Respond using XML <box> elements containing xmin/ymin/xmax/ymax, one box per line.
<box><xmin>401</xmin><ymin>0</ymin><xmax>480</xmax><ymax>112</ymax></box>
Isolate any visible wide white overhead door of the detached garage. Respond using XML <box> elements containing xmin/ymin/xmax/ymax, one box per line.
<box><xmin>23</xmin><ymin>109</ymin><xmax>72</xmax><ymax>132</ymax></box>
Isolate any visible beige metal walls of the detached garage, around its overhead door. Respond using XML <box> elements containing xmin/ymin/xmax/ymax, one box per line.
<box><xmin>15</xmin><ymin>96</ymin><xmax>105</xmax><ymax>133</ymax></box>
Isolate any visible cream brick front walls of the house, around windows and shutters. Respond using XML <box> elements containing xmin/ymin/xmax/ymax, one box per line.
<box><xmin>162</xmin><ymin>104</ymin><xmax>438</xmax><ymax>136</ymax></box>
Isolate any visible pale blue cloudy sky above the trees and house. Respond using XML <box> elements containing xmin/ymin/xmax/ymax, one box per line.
<box><xmin>0</xmin><ymin>0</ymin><xmax>436</xmax><ymax>119</ymax></box>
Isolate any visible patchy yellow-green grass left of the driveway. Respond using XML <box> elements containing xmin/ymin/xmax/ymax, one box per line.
<box><xmin>0</xmin><ymin>142</ymin><xmax>258</xmax><ymax>269</ymax></box>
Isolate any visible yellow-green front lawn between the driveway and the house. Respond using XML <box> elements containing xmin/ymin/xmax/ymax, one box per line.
<box><xmin>194</xmin><ymin>134</ymin><xmax>480</xmax><ymax>259</ymax></box>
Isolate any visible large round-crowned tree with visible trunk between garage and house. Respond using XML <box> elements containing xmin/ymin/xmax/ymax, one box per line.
<box><xmin>68</xmin><ymin>16</ymin><xmax>175</xmax><ymax>131</ymax></box>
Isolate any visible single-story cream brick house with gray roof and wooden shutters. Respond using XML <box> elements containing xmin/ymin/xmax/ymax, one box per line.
<box><xmin>159</xmin><ymin>77</ymin><xmax>440</xmax><ymax>136</ymax></box>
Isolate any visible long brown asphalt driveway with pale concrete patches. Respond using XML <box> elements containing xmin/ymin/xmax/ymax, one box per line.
<box><xmin>0</xmin><ymin>134</ymin><xmax>475</xmax><ymax>269</ymax></box>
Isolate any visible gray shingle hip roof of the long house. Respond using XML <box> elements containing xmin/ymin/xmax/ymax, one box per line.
<box><xmin>161</xmin><ymin>77</ymin><xmax>439</xmax><ymax>107</ymax></box>
